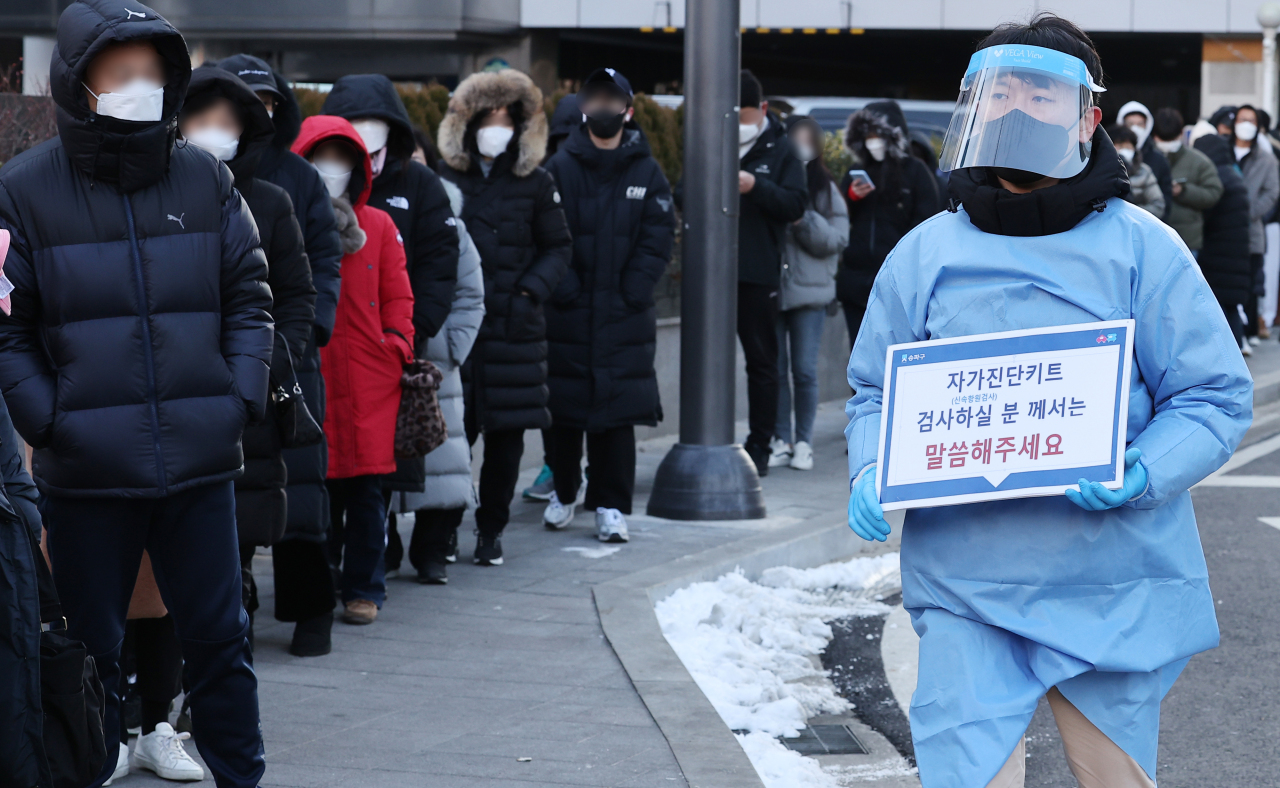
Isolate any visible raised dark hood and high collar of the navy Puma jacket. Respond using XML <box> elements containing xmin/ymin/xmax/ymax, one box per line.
<box><xmin>49</xmin><ymin>0</ymin><xmax>191</xmax><ymax>193</ymax></box>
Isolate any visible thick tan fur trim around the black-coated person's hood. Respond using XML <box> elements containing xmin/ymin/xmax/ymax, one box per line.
<box><xmin>438</xmin><ymin>69</ymin><xmax>547</xmax><ymax>178</ymax></box>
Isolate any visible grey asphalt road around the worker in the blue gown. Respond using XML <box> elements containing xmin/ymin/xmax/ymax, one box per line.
<box><xmin>823</xmin><ymin>404</ymin><xmax>1280</xmax><ymax>788</ymax></box>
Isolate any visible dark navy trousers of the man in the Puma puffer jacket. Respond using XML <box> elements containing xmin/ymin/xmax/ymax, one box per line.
<box><xmin>44</xmin><ymin>481</ymin><xmax>266</xmax><ymax>788</ymax></box>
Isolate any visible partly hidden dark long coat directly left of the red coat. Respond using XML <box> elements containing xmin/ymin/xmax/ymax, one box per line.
<box><xmin>218</xmin><ymin>55</ymin><xmax>342</xmax><ymax>541</ymax></box>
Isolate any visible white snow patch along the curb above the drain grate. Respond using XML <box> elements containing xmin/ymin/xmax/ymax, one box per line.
<box><xmin>654</xmin><ymin>553</ymin><xmax>900</xmax><ymax>788</ymax></box>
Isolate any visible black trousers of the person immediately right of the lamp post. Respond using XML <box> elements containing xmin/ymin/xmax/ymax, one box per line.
<box><xmin>737</xmin><ymin>281</ymin><xmax>778</xmax><ymax>445</ymax></box>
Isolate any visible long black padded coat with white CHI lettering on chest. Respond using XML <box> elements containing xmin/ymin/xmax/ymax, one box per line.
<box><xmin>547</xmin><ymin>123</ymin><xmax>676</xmax><ymax>431</ymax></box>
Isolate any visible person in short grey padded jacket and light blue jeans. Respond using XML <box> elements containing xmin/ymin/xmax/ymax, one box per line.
<box><xmin>769</xmin><ymin>116</ymin><xmax>849</xmax><ymax>471</ymax></box>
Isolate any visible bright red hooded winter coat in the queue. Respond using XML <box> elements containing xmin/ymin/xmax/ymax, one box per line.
<box><xmin>293</xmin><ymin>115</ymin><xmax>413</xmax><ymax>478</ymax></box>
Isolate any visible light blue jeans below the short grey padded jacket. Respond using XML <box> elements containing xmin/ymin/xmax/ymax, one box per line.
<box><xmin>773</xmin><ymin>307</ymin><xmax>827</xmax><ymax>444</ymax></box>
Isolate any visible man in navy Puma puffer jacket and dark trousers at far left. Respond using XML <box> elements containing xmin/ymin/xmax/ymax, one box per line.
<box><xmin>0</xmin><ymin>0</ymin><xmax>273</xmax><ymax>788</ymax></box>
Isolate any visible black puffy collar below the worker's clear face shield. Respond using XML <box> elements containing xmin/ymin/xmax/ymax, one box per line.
<box><xmin>947</xmin><ymin>125</ymin><xmax>1129</xmax><ymax>237</ymax></box>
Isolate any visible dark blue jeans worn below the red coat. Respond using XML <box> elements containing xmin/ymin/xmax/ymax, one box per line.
<box><xmin>325</xmin><ymin>476</ymin><xmax>387</xmax><ymax>608</ymax></box>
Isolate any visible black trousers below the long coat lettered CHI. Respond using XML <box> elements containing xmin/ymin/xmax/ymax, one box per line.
<box><xmin>552</xmin><ymin>425</ymin><xmax>636</xmax><ymax>514</ymax></box>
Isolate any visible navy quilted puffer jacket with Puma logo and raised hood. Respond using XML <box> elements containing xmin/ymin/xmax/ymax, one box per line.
<box><xmin>0</xmin><ymin>0</ymin><xmax>273</xmax><ymax>498</ymax></box>
